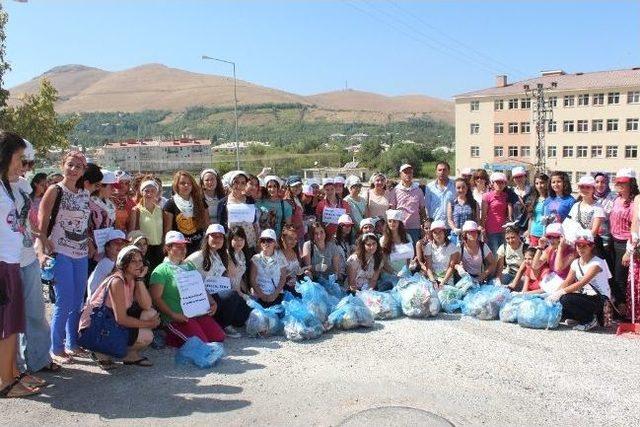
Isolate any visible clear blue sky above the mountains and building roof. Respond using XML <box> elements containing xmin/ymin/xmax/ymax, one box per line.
<box><xmin>3</xmin><ymin>0</ymin><xmax>640</xmax><ymax>98</ymax></box>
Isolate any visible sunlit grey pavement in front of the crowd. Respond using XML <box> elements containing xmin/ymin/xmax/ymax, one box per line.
<box><xmin>0</xmin><ymin>315</ymin><xmax>640</xmax><ymax>426</ymax></box>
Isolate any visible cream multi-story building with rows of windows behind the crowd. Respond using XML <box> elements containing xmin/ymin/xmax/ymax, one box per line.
<box><xmin>454</xmin><ymin>68</ymin><xmax>640</xmax><ymax>182</ymax></box>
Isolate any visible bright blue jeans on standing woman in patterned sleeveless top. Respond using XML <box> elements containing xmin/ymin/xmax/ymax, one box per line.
<box><xmin>51</xmin><ymin>254</ymin><xmax>88</xmax><ymax>354</ymax></box>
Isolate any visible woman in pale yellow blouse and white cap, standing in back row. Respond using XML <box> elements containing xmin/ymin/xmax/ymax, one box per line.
<box><xmin>129</xmin><ymin>177</ymin><xmax>164</xmax><ymax>271</ymax></box>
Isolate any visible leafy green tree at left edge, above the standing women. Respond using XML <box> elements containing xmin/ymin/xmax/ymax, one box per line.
<box><xmin>0</xmin><ymin>79</ymin><xmax>79</xmax><ymax>154</ymax></box>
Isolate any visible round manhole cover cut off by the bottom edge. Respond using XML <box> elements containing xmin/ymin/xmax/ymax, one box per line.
<box><xmin>340</xmin><ymin>406</ymin><xmax>453</xmax><ymax>427</ymax></box>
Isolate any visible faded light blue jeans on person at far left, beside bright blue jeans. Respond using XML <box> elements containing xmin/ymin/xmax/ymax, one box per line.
<box><xmin>18</xmin><ymin>260</ymin><xmax>51</xmax><ymax>372</ymax></box>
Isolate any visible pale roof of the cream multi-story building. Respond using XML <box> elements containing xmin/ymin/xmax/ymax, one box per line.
<box><xmin>454</xmin><ymin>67</ymin><xmax>640</xmax><ymax>99</ymax></box>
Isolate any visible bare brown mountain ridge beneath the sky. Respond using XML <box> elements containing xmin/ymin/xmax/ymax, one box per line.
<box><xmin>9</xmin><ymin>64</ymin><xmax>454</xmax><ymax>123</ymax></box>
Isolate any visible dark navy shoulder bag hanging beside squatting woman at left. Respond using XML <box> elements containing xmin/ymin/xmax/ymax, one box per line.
<box><xmin>78</xmin><ymin>277</ymin><xmax>129</xmax><ymax>358</ymax></box>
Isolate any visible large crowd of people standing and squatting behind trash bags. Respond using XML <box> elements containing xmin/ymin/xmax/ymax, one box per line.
<box><xmin>0</xmin><ymin>132</ymin><xmax>640</xmax><ymax>397</ymax></box>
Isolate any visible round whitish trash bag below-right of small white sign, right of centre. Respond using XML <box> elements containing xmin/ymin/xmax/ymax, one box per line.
<box><xmin>393</xmin><ymin>273</ymin><xmax>440</xmax><ymax>318</ymax></box>
